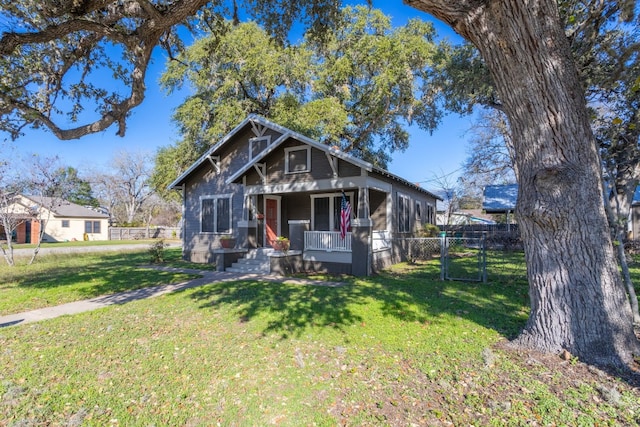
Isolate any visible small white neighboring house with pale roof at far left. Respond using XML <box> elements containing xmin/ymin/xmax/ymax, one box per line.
<box><xmin>11</xmin><ymin>195</ymin><xmax>109</xmax><ymax>243</ymax></box>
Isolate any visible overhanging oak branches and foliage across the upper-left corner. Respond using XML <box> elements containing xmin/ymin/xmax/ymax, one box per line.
<box><xmin>0</xmin><ymin>0</ymin><xmax>350</xmax><ymax>139</ymax></box>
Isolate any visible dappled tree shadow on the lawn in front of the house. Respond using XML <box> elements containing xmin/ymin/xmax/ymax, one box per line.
<box><xmin>191</xmin><ymin>265</ymin><xmax>528</xmax><ymax>338</ymax></box>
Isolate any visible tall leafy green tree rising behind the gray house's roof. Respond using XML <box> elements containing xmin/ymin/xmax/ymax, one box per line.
<box><xmin>153</xmin><ymin>6</ymin><xmax>441</xmax><ymax>191</ymax></box>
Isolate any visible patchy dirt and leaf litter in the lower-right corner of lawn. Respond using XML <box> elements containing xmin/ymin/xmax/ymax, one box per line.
<box><xmin>330</xmin><ymin>341</ymin><xmax>640</xmax><ymax>426</ymax></box>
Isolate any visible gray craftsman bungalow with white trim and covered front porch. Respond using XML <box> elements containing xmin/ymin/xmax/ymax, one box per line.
<box><xmin>170</xmin><ymin>115</ymin><xmax>439</xmax><ymax>275</ymax></box>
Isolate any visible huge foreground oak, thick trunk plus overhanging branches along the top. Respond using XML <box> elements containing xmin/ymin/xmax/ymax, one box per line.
<box><xmin>0</xmin><ymin>0</ymin><xmax>640</xmax><ymax>366</ymax></box>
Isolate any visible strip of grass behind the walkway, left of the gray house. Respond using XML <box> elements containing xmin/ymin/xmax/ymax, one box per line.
<box><xmin>0</xmin><ymin>248</ymin><xmax>203</xmax><ymax>315</ymax></box>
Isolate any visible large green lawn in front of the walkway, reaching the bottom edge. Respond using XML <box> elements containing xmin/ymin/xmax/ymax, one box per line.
<box><xmin>0</xmin><ymin>251</ymin><xmax>640</xmax><ymax>426</ymax></box>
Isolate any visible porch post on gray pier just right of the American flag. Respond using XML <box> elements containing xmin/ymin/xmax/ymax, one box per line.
<box><xmin>351</xmin><ymin>187</ymin><xmax>373</xmax><ymax>276</ymax></box>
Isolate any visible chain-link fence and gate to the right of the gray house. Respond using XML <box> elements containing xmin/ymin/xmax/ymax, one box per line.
<box><xmin>398</xmin><ymin>236</ymin><xmax>487</xmax><ymax>282</ymax></box>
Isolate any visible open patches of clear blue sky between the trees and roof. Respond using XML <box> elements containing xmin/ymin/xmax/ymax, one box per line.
<box><xmin>1</xmin><ymin>0</ymin><xmax>472</xmax><ymax>194</ymax></box>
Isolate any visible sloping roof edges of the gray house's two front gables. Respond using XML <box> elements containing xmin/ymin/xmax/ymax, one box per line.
<box><xmin>169</xmin><ymin>114</ymin><xmax>442</xmax><ymax>200</ymax></box>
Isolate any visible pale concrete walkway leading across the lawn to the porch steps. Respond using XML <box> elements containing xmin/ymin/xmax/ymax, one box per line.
<box><xmin>0</xmin><ymin>266</ymin><xmax>343</xmax><ymax>328</ymax></box>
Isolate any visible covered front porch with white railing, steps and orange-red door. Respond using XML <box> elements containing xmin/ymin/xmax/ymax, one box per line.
<box><xmin>238</xmin><ymin>188</ymin><xmax>391</xmax><ymax>275</ymax></box>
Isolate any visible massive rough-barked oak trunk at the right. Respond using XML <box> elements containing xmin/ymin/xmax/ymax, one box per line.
<box><xmin>408</xmin><ymin>0</ymin><xmax>640</xmax><ymax>365</ymax></box>
